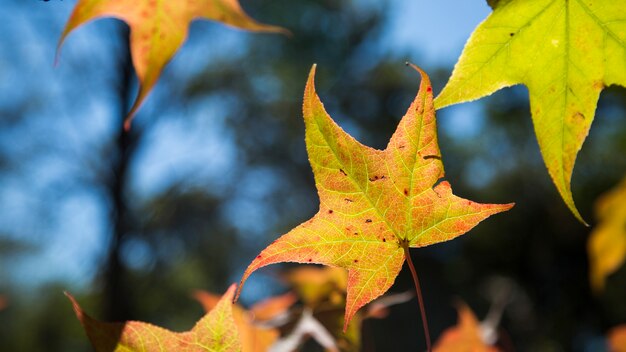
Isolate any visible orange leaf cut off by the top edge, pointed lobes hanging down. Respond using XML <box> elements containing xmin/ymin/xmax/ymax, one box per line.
<box><xmin>57</xmin><ymin>0</ymin><xmax>288</xmax><ymax>129</ymax></box>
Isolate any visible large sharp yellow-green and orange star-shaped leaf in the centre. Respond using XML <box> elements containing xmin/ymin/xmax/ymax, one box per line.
<box><xmin>237</xmin><ymin>66</ymin><xmax>513</xmax><ymax>330</ymax></box>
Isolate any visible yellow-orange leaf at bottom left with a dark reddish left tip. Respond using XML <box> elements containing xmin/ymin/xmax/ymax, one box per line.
<box><xmin>66</xmin><ymin>285</ymin><xmax>241</xmax><ymax>352</ymax></box>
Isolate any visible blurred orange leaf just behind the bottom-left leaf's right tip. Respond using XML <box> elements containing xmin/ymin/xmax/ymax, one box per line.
<box><xmin>194</xmin><ymin>291</ymin><xmax>296</xmax><ymax>352</ymax></box>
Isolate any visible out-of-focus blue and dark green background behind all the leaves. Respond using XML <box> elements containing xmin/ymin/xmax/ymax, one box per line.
<box><xmin>0</xmin><ymin>0</ymin><xmax>626</xmax><ymax>351</ymax></box>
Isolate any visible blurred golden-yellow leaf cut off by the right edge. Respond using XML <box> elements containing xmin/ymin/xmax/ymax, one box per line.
<box><xmin>587</xmin><ymin>179</ymin><xmax>626</xmax><ymax>292</ymax></box>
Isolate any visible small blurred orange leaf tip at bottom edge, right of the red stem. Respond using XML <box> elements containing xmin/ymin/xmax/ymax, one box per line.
<box><xmin>433</xmin><ymin>304</ymin><xmax>498</xmax><ymax>352</ymax></box>
